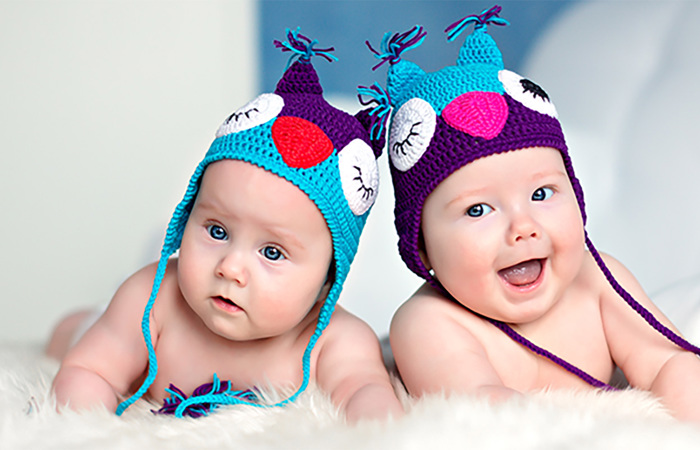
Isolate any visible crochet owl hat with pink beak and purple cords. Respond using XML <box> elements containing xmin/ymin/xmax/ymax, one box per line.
<box><xmin>367</xmin><ymin>6</ymin><xmax>700</xmax><ymax>388</ymax></box>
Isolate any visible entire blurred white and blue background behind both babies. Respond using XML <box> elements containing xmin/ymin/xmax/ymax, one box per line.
<box><xmin>0</xmin><ymin>0</ymin><xmax>700</xmax><ymax>342</ymax></box>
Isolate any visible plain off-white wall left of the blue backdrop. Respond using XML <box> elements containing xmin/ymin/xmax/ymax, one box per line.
<box><xmin>0</xmin><ymin>0</ymin><xmax>258</xmax><ymax>341</ymax></box>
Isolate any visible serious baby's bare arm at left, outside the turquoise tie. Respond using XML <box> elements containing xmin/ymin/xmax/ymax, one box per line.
<box><xmin>53</xmin><ymin>266</ymin><xmax>159</xmax><ymax>411</ymax></box>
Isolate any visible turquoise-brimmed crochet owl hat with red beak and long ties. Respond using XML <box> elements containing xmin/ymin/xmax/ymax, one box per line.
<box><xmin>117</xmin><ymin>29</ymin><xmax>384</xmax><ymax>416</ymax></box>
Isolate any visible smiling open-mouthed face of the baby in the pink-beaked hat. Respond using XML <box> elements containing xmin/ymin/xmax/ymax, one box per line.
<box><xmin>422</xmin><ymin>148</ymin><xmax>585</xmax><ymax>323</ymax></box>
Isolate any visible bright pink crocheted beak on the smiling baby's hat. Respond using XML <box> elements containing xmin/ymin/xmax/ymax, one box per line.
<box><xmin>442</xmin><ymin>92</ymin><xmax>508</xmax><ymax>139</ymax></box>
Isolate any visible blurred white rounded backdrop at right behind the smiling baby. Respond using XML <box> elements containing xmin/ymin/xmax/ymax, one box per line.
<box><xmin>524</xmin><ymin>0</ymin><xmax>700</xmax><ymax>294</ymax></box>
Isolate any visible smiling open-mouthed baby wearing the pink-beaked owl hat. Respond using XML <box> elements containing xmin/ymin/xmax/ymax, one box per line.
<box><xmin>378</xmin><ymin>7</ymin><xmax>700</xmax><ymax>421</ymax></box>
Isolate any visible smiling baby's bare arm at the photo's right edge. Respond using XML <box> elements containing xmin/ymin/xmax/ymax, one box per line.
<box><xmin>601</xmin><ymin>255</ymin><xmax>700</xmax><ymax>422</ymax></box>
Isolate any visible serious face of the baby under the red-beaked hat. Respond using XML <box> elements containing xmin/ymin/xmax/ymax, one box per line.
<box><xmin>178</xmin><ymin>160</ymin><xmax>333</xmax><ymax>340</ymax></box>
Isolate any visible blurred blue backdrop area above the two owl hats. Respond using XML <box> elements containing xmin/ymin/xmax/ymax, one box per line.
<box><xmin>259</xmin><ymin>0</ymin><xmax>577</xmax><ymax>96</ymax></box>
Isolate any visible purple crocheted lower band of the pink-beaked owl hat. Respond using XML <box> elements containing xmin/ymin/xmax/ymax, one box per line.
<box><xmin>391</xmin><ymin>94</ymin><xmax>586</xmax><ymax>282</ymax></box>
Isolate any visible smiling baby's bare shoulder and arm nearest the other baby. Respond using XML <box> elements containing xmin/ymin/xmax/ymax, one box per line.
<box><xmin>390</xmin><ymin>285</ymin><xmax>519</xmax><ymax>400</ymax></box>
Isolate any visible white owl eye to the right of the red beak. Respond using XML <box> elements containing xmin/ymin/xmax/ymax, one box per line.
<box><xmin>338</xmin><ymin>139</ymin><xmax>379</xmax><ymax>216</ymax></box>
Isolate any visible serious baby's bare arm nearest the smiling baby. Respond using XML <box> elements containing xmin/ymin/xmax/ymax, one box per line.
<box><xmin>316</xmin><ymin>308</ymin><xmax>403</xmax><ymax>423</ymax></box>
